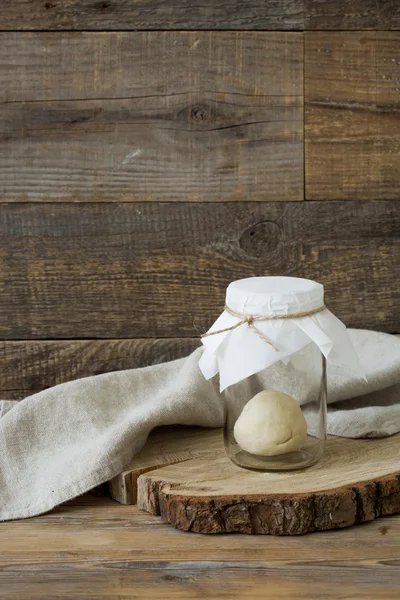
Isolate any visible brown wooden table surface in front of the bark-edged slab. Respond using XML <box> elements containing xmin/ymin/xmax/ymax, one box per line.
<box><xmin>0</xmin><ymin>496</ymin><xmax>400</xmax><ymax>600</ymax></box>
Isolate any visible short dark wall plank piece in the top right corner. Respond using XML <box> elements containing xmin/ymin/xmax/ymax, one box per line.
<box><xmin>304</xmin><ymin>0</ymin><xmax>400</xmax><ymax>30</ymax></box>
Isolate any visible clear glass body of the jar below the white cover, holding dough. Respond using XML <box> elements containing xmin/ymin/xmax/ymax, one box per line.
<box><xmin>223</xmin><ymin>343</ymin><xmax>327</xmax><ymax>471</ymax></box>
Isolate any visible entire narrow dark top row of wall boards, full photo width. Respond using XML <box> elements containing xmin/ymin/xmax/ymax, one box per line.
<box><xmin>0</xmin><ymin>0</ymin><xmax>400</xmax><ymax>31</ymax></box>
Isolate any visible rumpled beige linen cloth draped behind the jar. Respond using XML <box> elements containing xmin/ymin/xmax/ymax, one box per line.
<box><xmin>0</xmin><ymin>330</ymin><xmax>400</xmax><ymax>521</ymax></box>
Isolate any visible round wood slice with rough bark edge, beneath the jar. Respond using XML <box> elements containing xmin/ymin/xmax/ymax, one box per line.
<box><xmin>138</xmin><ymin>430</ymin><xmax>400</xmax><ymax>535</ymax></box>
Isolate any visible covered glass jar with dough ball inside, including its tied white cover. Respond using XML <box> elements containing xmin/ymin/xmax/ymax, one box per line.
<box><xmin>199</xmin><ymin>277</ymin><xmax>359</xmax><ymax>471</ymax></box>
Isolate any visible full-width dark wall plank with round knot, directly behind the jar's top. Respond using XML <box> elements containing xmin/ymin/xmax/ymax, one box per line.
<box><xmin>0</xmin><ymin>201</ymin><xmax>400</xmax><ymax>340</ymax></box>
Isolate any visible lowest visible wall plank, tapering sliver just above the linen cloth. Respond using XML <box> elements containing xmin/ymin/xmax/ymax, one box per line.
<box><xmin>0</xmin><ymin>338</ymin><xmax>200</xmax><ymax>400</ymax></box>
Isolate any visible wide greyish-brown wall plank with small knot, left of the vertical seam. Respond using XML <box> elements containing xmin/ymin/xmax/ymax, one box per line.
<box><xmin>0</xmin><ymin>32</ymin><xmax>304</xmax><ymax>202</ymax></box>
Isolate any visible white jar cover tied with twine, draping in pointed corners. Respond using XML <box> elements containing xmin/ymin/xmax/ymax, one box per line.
<box><xmin>199</xmin><ymin>277</ymin><xmax>364</xmax><ymax>392</ymax></box>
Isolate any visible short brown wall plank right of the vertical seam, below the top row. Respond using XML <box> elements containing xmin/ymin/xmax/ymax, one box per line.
<box><xmin>305</xmin><ymin>32</ymin><xmax>400</xmax><ymax>200</ymax></box>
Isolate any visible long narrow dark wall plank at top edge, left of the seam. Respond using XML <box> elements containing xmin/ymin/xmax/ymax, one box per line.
<box><xmin>0</xmin><ymin>0</ymin><xmax>304</xmax><ymax>31</ymax></box>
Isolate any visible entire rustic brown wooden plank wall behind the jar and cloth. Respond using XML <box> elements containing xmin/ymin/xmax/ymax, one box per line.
<box><xmin>0</xmin><ymin>0</ymin><xmax>400</xmax><ymax>398</ymax></box>
